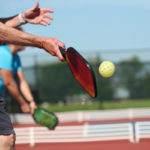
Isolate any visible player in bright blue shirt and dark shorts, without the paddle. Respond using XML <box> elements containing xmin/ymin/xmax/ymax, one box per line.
<box><xmin>0</xmin><ymin>29</ymin><xmax>37</xmax><ymax>150</ymax></box>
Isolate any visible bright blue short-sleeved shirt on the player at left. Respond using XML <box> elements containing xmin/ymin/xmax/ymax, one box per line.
<box><xmin>0</xmin><ymin>45</ymin><xmax>22</xmax><ymax>96</ymax></box>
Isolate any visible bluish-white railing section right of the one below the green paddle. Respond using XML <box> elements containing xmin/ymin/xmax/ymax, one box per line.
<box><xmin>86</xmin><ymin>123</ymin><xmax>134</xmax><ymax>142</ymax></box>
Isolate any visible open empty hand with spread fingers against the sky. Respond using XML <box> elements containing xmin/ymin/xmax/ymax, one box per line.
<box><xmin>22</xmin><ymin>2</ymin><xmax>53</xmax><ymax>26</ymax></box>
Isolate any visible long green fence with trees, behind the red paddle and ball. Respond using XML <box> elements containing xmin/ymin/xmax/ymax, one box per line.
<box><xmin>7</xmin><ymin>57</ymin><xmax>150</xmax><ymax>112</ymax></box>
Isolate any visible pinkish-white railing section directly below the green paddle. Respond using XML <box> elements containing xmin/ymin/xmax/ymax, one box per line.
<box><xmin>15</xmin><ymin>125</ymin><xmax>85</xmax><ymax>146</ymax></box>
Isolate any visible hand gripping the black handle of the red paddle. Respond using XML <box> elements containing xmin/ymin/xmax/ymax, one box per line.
<box><xmin>41</xmin><ymin>38</ymin><xmax>65</xmax><ymax>61</ymax></box>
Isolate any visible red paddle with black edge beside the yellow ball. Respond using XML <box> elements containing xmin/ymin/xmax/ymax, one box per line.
<box><xmin>60</xmin><ymin>47</ymin><xmax>97</xmax><ymax>98</ymax></box>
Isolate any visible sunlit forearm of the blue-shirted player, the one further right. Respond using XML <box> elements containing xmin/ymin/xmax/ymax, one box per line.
<box><xmin>19</xmin><ymin>80</ymin><xmax>34</xmax><ymax>102</ymax></box>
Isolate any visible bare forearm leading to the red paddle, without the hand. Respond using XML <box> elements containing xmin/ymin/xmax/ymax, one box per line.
<box><xmin>0</xmin><ymin>23</ymin><xmax>42</xmax><ymax>48</ymax></box>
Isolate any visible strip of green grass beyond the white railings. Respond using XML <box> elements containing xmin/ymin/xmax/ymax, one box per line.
<box><xmin>40</xmin><ymin>99</ymin><xmax>150</xmax><ymax>112</ymax></box>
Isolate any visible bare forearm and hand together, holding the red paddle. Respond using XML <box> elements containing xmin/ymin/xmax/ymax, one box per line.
<box><xmin>0</xmin><ymin>23</ymin><xmax>65</xmax><ymax>61</ymax></box>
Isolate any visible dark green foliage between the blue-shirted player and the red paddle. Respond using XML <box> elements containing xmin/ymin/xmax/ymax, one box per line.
<box><xmin>37</xmin><ymin>63</ymin><xmax>86</xmax><ymax>102</ymax></box>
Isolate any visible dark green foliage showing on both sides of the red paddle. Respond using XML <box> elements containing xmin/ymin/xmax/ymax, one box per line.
<box><xmin>36</xmin><ymin>58</ymin><xmax>113</xmax><ymax>102</ymax></box>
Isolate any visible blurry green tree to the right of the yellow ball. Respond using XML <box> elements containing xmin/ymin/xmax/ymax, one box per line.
<box><xmin>118</xmin><ymin>57</ymin><xmax>143</xmax><ymax>98</ymax></box>
